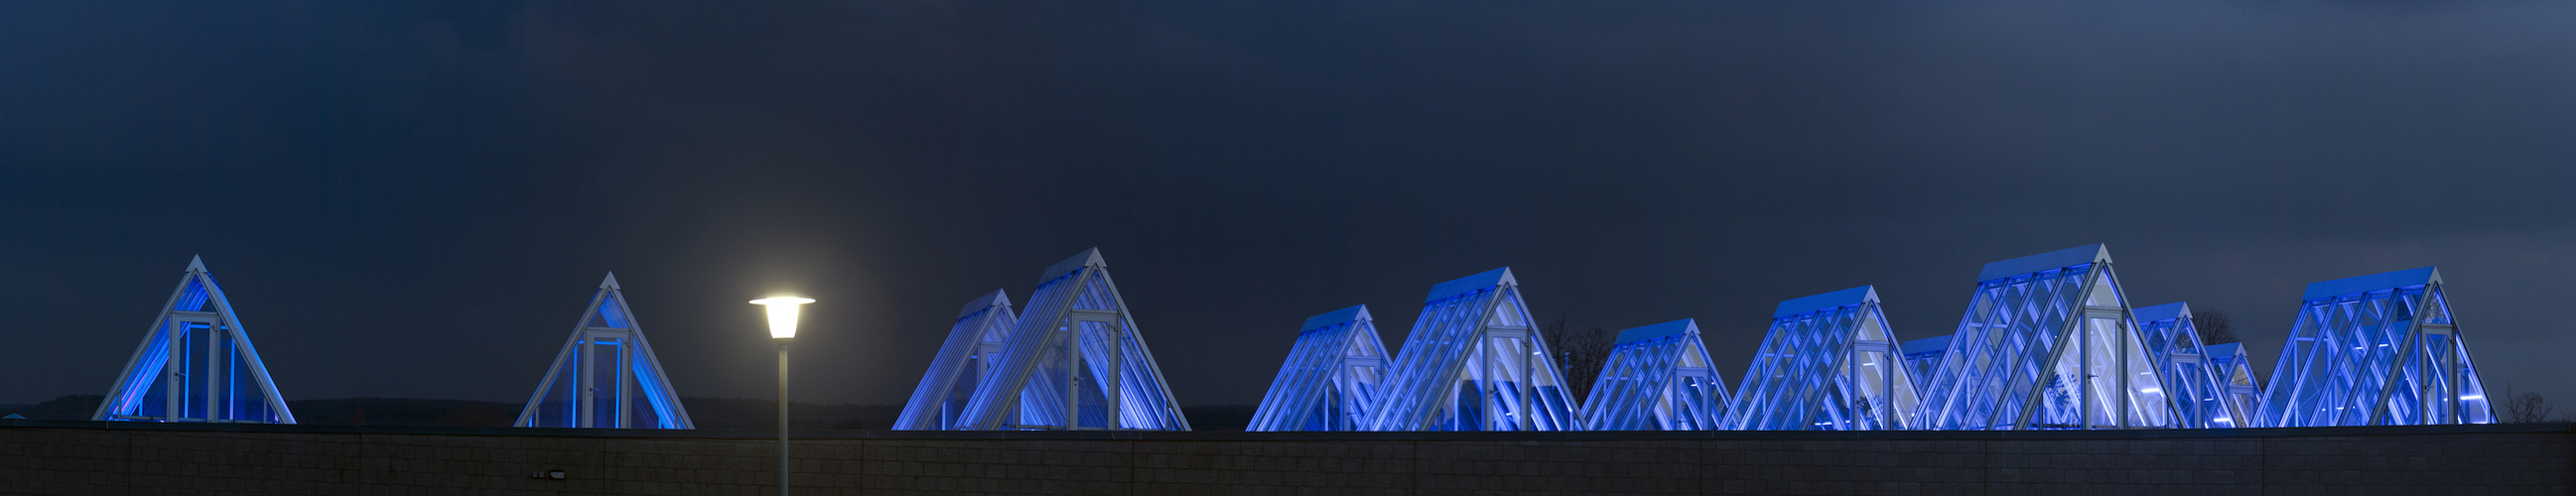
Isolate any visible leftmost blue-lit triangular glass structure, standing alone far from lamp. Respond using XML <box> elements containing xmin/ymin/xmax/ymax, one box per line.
<box><xmin>90</xmin><ymin>257</ymin><xmax>296</xmax><ymax>424</ymax></box>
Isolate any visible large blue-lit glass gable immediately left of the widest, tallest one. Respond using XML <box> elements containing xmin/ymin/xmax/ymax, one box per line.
<box><xmin>1728</xmin><ymin>286</ymin><xmax>1922</xmax><ymax>432</ymax></box>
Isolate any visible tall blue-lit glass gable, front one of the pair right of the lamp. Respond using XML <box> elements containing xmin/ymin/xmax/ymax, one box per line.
<box><xmin>958</xmin><ymin>249</ymin><xmax>1190</xmax><ymax>432</ymax></box>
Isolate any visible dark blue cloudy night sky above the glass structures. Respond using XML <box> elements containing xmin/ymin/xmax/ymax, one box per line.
<box><xmin>0</xmin><ymin>0</ymin><xmax>2576</xmax><ymax>412</ymax></box>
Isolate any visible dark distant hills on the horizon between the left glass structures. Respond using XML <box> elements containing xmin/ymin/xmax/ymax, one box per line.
<box><xmin>0</xmin><ymin>393</ymin><xmax>1252</xmax><ymax>432</ymax></box>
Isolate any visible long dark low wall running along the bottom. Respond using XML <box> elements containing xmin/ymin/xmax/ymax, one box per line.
<box><xmin>0</xmin><ymin>422</ymin><xmax>2576</xmax><ymax>496</ymax></box>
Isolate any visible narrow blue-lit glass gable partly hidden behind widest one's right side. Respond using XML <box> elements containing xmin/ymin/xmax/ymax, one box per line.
<box><xmin>2130</xmin><ymin>304</ymin><xmax>2248</xmax><ymax>430</ymax></box>
